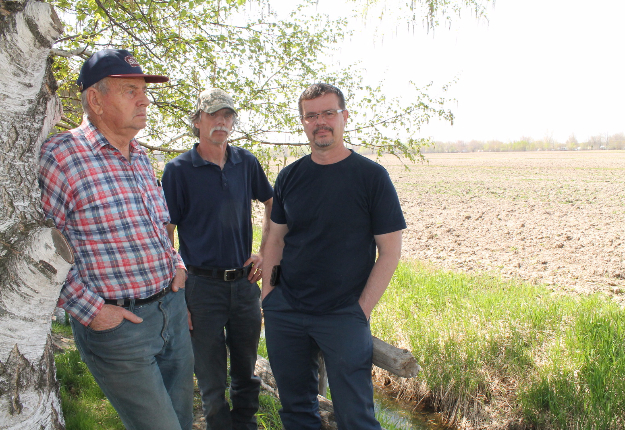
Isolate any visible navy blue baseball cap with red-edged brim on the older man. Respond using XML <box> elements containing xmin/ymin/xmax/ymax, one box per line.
<box><xmin>76</xmin><ymin>49</ymin><xmax>169</xmax><ymax>91</ymax></box>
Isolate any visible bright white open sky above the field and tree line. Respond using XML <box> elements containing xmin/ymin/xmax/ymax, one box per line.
<box><xmin>271</xmin><ymin>0</ymin><xmax>625</xmax><ymax>142</ymax></box>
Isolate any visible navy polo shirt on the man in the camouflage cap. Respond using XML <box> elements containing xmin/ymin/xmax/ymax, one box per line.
<box><xmin>162</xmin><ymin>143</ymin><xmax>273</xmax><ymax>269</ymax></box>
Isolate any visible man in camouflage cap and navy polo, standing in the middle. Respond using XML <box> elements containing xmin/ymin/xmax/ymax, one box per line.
<box><xmin>163</xmin><ymin>88</ymin><xmax>273</xmax><ymax>430</ymax></box>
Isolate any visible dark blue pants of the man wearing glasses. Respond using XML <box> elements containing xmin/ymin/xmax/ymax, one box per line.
<box><xmin>263</xmin><ymin>287</ymin><xmax>381</xmax><ymax>430</ymax></box>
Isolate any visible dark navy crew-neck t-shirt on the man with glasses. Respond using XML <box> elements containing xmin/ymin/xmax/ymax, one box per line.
<box><xmin>271</xmin><ymin>153</ymin><xmax>406</xmax><ymax>314</ymax></box>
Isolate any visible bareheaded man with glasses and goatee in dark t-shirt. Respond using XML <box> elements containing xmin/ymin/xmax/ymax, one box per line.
<box><xmin>262</xmin><ymin>84</ymin><xmax>406</xmax><ymax>430</ymax></box>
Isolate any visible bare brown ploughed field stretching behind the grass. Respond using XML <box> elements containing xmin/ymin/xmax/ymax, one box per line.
<box><xmin>381</xmin><ymin>151</ymin><xmax>625</xmax><ymax>305</ymax></box>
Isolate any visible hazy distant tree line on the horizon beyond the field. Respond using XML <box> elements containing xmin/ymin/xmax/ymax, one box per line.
<box><xmin>421</xmin><ymin>133</ymin><xmax>625</xmax><ymax>153</ymax></box>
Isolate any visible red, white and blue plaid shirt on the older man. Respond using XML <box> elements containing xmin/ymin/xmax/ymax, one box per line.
<box><xmin>39</xmin><ymin>120</ymin><xmax>184</xmax><ymax>325</ymax></box>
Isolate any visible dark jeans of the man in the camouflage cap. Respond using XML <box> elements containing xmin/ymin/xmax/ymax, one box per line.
<box><xmin>185</xmin><ymin>274</ymin><xmax>261</xmax><ymax>430</ymax></box>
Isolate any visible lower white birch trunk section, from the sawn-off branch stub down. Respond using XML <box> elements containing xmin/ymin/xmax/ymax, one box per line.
<box><xmin>0</xmin><ymin>228</ymin><xmax>73</xmax><ymax>430</ymax></box>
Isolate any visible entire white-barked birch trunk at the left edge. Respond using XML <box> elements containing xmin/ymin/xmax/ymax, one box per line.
<box><xmin>0</xmin><ymin>0</ymin><xmax>73</xmax><ymax>430</ymax></box>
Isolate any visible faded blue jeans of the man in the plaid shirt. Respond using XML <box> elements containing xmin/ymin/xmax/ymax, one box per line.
<box><xmin>71</xmin><ymin>291</ymin><xmax>193</xmax><ymax>430</ymax></box>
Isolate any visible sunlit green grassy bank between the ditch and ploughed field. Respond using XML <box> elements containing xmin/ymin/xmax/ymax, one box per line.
<box><xmin>372</xmin><ymin>263</ymin><xmax>625</xmax><ymax>429</ymax></box>
